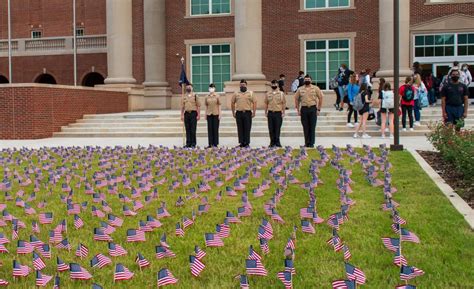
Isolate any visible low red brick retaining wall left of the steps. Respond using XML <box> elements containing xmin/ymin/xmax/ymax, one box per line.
<box><xmin>0</xmin><ymin>85</ymin><xmax>128</xmax><ymax>139</ymax></box>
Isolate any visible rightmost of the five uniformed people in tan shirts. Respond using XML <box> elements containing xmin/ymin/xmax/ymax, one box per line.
<box><xmin>295</xmin><ymin>74</ymin><xmax>323</xmax><ymax>148</ymax></box>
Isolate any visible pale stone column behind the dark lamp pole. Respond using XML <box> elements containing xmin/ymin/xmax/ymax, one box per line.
<box><xmin>377</xmin><ymin>0</ymin><xmax>411</xmax><ymax>77</ymax></box>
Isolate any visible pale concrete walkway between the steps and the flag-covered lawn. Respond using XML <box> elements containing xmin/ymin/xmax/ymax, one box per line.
<box><xmin>0</xmin><ymin>136</ymin><xmax>433</xmax><ymax>150</ymax></box>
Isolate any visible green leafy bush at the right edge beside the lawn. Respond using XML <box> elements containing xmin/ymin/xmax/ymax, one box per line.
<box><xmin>428</xmin><ymin>123</ymin><xmax>474</xmax><ymax>183</ymax></box>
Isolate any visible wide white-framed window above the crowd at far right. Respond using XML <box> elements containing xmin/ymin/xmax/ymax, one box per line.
<box><xmin>415</xmin><ymin>33</ymin><xmax>474</xmax><ymax>57</ymax></box>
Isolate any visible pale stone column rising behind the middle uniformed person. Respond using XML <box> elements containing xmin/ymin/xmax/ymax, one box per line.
<box><xmin>232</xmin><ymin>0</ymin><xmax>265</xmax><ymax>80</ymax></box>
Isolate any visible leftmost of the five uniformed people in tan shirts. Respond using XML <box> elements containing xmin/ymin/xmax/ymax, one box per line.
<box><xmin>181</xmin><ymin>84</ymin><xmax>201</xmax><ymax>148</ymax></box>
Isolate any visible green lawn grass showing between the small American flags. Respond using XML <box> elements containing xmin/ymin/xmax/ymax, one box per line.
<box><xmin>0</xmin><ymin>149</ymin><xmax>474</xmax><ymax>289</ymax></box>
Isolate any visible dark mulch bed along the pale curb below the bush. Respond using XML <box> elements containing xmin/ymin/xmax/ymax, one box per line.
<box><xmin>418</xmin><ymin>151</ymin><xmax>474</xmax><ymax>209</ymax></box>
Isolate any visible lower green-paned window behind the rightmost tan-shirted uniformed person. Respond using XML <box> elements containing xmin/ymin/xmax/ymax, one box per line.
<box><xmin>305</xmin><ymin>39</ymin><xmax>350</xmax><ymax>89</ymax></box>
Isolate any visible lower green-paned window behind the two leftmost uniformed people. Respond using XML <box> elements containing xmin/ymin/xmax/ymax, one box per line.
<box><xmin>191</xmin><ymin>44</ymin><xmax>231</xmax><ymax>92</ymax></box>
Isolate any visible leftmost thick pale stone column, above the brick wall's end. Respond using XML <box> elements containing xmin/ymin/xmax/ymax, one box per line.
<box><xmin>105</xmin><ymin>0</ymin><xmax>136</xmax><ymax>84</ymax></box>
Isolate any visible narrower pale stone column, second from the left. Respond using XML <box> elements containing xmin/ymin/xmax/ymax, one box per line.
<box><xmin>143</xmin><ymin>0</ymin><xmax>168</xmax><ymax>87</ymax></box>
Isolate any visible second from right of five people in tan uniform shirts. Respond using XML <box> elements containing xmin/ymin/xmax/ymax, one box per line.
<box><xmin>265</xmin><ymin>79</ymin><xmax>286</xmax><ymax>147</ymax></box>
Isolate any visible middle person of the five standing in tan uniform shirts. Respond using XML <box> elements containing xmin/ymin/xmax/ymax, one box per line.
<box><xmin>231</xmin><ymin>79</ymin><xmax>257</xmax><ymax>147</ymax></box>
